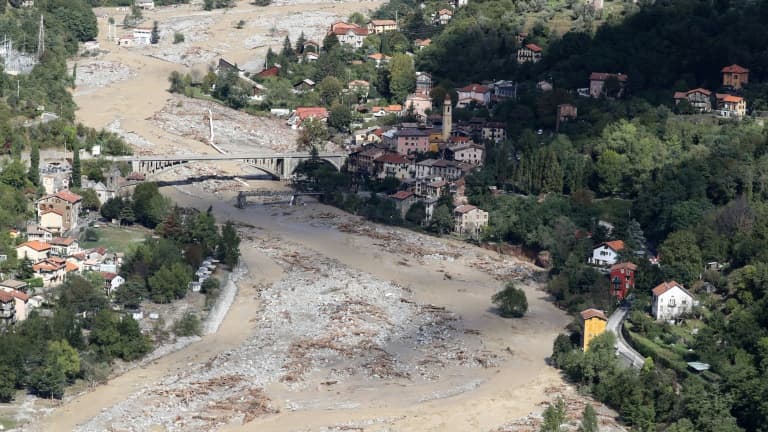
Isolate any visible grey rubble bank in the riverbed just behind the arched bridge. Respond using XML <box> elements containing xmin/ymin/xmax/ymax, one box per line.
<box><xmin>150</xmin><ymin>95</ymin><xmax>298</xmax><ymax>153</ymax></box>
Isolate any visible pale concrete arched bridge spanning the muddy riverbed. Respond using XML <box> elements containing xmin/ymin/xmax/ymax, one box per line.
<box><xmin>106</xmin><ymin>152</ymin><xmax>347</xmax><ymax>180</ymax></box>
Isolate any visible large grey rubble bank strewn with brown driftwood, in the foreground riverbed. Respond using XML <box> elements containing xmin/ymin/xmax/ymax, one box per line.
<box><xmin>78</xmin><ymin>238</ymin><xmax>488</xmax><ymax>432</ymax></box>
